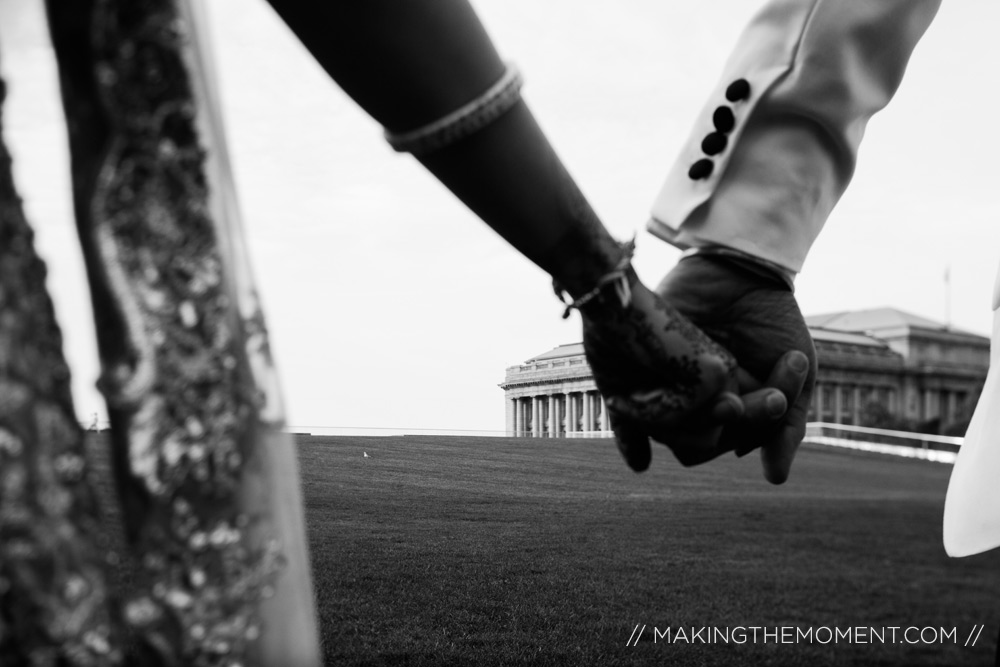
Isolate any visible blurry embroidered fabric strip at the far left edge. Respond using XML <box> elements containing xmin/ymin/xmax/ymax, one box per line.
<box><xmin>0</xmin><ymin>73</ymin><xmax>122</xmax><ymax>667</ymax></box>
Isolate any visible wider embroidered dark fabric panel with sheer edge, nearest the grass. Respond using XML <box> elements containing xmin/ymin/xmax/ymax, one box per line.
<box><xmin>40</xmin><ymin>0</ymin><xmax>297</xmax><ymax>667</ymax></box>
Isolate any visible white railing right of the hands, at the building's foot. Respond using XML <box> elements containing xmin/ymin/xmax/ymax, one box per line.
<box><xmin>803</xmin><ymin>422</ymin><xmax>963</xmax><ymax>463</ymax></box>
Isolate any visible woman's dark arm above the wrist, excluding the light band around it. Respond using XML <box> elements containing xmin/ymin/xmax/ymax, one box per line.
<box><xmin>270</xmin><ymin>0</ymin><xmax>620</xmax><ymax>294</ymax></box>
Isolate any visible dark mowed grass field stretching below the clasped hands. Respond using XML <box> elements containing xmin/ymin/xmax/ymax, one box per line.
<box><xmin>84</xmin><ymin>436</ymin><xmax>1000</xmax><ymax>666</ymax></box>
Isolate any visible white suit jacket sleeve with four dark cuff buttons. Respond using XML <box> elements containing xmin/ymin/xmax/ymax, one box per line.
<box><xmin>647</xmin><ymin>0</ymin><xmax>940</xmax><ymax>272</ymax></box>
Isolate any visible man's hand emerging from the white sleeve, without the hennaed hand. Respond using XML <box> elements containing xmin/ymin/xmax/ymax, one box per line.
<box><xmin>654</xmin><ymin>255</ymin><xmax>816</xmax><ymax>484</ymax></box>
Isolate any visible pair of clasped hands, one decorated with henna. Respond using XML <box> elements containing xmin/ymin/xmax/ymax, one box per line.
<box><xmin>580</xmin><ymin>248</ymin><xmax>816</xmax><ymax>484</ymax></box>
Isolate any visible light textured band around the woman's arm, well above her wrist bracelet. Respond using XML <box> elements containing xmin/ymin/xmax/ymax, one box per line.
<box><xmin>385</xmin><ymin>63</ymin><xmax>524</xmax><ymax>155</ymax></box>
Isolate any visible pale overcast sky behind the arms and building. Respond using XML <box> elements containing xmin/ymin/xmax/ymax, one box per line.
<box><xmin>0</xmin><ymin>0</ymin><xmax>1000</xmax><ymax>431</ymax></box>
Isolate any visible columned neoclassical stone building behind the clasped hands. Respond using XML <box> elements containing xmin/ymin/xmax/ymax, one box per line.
<box><xmin>500</xmin><ymin>308</ymin><xmax>990</xmax><ymax>437</ymax></box>
